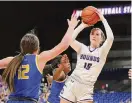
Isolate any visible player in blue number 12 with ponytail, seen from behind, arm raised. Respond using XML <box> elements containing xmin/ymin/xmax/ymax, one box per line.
<box><xmin>0</xmin><ymin>16</ymin><xmax>79</xmax><ymax>103</ymax></box>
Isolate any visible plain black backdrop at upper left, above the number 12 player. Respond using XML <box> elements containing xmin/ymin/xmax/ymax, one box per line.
<box><xmin>0</xmin><ymin>1</ymin><xmax>130</xmax><ymax>77</ymax></box>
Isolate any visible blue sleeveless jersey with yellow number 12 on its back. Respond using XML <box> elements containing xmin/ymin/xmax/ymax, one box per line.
<box><xmin>9</xmin><ymin>54</ymin><xmax>42</xmax><ymax>100</ymax></box>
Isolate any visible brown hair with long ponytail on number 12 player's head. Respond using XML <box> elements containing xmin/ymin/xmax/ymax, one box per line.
<box><xmin>2</xmin><ymin>33</ymin><xmax>39</xmax><ymax>92</ymax></box>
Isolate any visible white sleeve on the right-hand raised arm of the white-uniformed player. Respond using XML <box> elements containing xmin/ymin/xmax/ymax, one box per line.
<box><xmin>100</xmin><ymin>19</ymin><xmax>114</xmax><ymax>58</ymax></box>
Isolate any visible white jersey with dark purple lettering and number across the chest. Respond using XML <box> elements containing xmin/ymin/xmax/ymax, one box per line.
<box><xmin>71</xmin><ymin>42</ymin><xmax>111</xmax><ymax>85</ymax></box>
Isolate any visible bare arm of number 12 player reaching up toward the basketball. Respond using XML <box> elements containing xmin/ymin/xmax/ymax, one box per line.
<box><xmin>39</xmin><ymin>16</ymin><xmax>79</xmax><ymax>62</ymax></box>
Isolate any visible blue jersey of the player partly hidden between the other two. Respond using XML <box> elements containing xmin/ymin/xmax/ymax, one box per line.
<box><xmin>48</xmin><ymin>81</ymin><xmax>65</xmax><ymax>103</ymax></box>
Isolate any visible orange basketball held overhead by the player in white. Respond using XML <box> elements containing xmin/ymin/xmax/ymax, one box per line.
<box><xmin>81</xmin><ymin>6</ymin><xmax>100</xmax><ymax>25</ymax></box>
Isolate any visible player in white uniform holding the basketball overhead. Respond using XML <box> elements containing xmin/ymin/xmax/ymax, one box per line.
<box><xmin>60</xmin><ymin>11</ymin><xmax>114</xmax><ymax>103</ymax></box>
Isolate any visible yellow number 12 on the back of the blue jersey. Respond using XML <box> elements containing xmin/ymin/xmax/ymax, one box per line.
<box><xmin>18</xmin><ymin>64</ymin><xmax>29</xmax><ymax>79</ymax></box>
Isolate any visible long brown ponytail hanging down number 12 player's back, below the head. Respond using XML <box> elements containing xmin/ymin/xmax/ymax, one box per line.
<box><xmin>2</xmin><ymin>53</ymin><xmax>24</xmax><ymax>92</ymax></box>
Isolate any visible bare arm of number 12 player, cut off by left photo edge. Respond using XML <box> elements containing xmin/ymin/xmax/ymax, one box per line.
<box><xmin>0</xmin><ymin>57</ymin><xmax>14</xmax><ymax>69</ymax></box>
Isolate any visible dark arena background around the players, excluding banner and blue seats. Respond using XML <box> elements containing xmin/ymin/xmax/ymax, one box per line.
<box><xmin>0</xmin><ymin>1</ymin><xmax>132</xmax><ymax>103</ymax></box>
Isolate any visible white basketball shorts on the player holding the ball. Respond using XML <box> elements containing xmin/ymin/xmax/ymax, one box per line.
<box><xmin>60</xmin><ymin>77</ymin><xmax>93</xmax><ymax>103</ymax></box>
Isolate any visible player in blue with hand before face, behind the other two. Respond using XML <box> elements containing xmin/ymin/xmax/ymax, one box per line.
<box><xmin>47</xmin><ymin>54</ymin><xmax>71</xmax><ymax>103</ymax></box>
